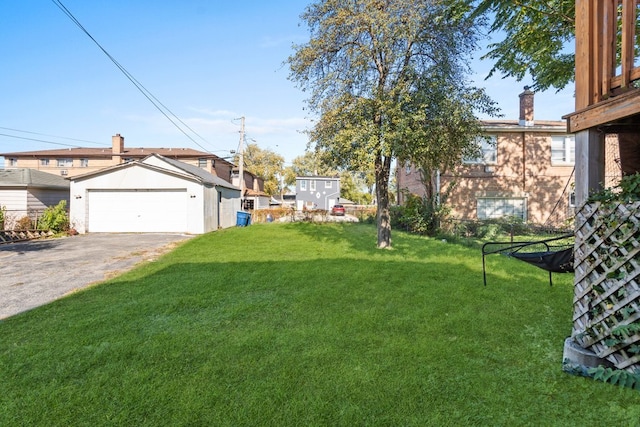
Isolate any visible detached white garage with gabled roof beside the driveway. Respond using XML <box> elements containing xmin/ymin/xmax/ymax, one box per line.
<box><xmin>70</xmin><ymin>154</ymin><xmax>240</xmax><ymax>234</ymax></box>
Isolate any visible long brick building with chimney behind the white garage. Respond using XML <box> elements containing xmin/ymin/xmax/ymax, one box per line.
<box><xmin>0</xmin><ymin>134</ymin><xmax>240</xmax><ymax>183</ymax></box>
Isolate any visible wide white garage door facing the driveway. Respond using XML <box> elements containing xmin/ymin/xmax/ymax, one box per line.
<box><xmin>87</xmin><ymin>189</ymin><xmax>187</xmax><ymax>233</ymax></box>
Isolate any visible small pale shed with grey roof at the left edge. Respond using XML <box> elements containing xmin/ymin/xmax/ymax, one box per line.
<box><xmin>0</xmin><ymin>168</ymin><xmax>69</xmax><ymax>229</ymax></box>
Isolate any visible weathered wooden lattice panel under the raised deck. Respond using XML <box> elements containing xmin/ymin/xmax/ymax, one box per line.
<box><xmin>572</xmin><ymin>202</ymin><xmax>640</xmax><ymax>370</ymax></box>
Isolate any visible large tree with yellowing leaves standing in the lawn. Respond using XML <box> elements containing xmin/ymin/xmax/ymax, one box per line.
<box><xmin>289</xmin><ymin>0</ymin><xmax>490</xmax><ymax>248</ymax></box>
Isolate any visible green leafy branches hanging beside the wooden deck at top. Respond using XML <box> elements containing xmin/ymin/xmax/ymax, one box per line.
<box><xmin>475</xmin><ymin>0</ymin><xmax>575</xmax><ymax>90</ymax></box>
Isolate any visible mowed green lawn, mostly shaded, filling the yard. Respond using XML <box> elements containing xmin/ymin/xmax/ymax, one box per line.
<box><xmin>0</xmin><ymin>223</ymin><xmax>640</xmax><ymax>426</ymax></box>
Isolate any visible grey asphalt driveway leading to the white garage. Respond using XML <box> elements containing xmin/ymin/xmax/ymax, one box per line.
<box><xmin>0</xmin><ymin>233</ymin><xmax>192</xmax><ymax>319</ymax></box>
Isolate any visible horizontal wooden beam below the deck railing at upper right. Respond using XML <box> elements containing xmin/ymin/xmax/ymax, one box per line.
<box><xmin>563</xmin><ymin>89</ymin><xmax>640</xmax><ymax>133</ymax></box>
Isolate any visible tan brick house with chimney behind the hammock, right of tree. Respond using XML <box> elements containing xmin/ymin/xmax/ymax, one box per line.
<box><xmin>396</xmin><ymin>87</ymin><xmax>616</xmax><ymax>226</ymax></box>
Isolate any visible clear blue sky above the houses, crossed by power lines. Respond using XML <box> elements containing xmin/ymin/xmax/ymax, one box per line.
<box><xmin>0</xmin><ymin>0</ymin><xmax>574</xmax><ymax>167</ymax></box>
